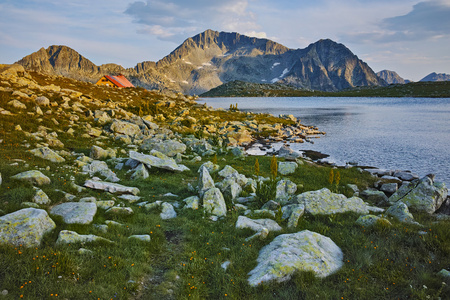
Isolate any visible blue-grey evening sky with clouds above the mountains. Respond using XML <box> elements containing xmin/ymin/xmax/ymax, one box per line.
<box><xmin>0</xmin><ymin>0</ymin><xmax>450</xmax><ymax>81</ymax></box>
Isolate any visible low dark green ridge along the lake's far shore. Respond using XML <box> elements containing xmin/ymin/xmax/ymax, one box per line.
<box><xmin>201</xmin><ymin>81</ymin><xmax>450</xmax><ymax>98</ymax></box>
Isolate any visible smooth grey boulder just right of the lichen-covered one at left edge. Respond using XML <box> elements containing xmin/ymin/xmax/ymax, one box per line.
<box><xmin>50</xmin><ymin>202</ymin><xmax>97</xmax><ymax>224</ymax></box>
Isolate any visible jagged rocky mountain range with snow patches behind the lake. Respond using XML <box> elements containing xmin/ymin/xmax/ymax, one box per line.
<box><xmin>18</xmin><ymin>30</ymin><xmax>386</xmax><ymax>94</ymax></box>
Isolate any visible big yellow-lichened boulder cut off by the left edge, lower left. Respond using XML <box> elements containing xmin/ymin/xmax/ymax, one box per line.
<box><xmin>0</xmin><ymin>208</ymin><xmax>56</xmax><ymax>248</ymax></box>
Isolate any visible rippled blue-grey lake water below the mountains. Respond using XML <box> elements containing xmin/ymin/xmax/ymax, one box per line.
<box><xmin>198</xmin><ymin>97</ymin><xmax>450</xmax><ymax>186</ymax></box>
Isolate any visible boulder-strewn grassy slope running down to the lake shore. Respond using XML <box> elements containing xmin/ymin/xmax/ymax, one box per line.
<box><xmin>0</xmin><ymin>65</ymin><xmax>450</xmax><ymax>299</ymax></box>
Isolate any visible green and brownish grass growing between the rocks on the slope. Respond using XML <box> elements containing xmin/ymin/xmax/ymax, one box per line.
<box><xmin>0</xmin><ymin>69</ymin><xmax>450</xmax><ymax>299</ymax></box>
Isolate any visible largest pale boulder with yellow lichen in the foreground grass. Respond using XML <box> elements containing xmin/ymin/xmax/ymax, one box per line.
<box><xmin>248</xmin><ymin>230</ymin><xmax>344</xmax><ymax>286</ymax></box>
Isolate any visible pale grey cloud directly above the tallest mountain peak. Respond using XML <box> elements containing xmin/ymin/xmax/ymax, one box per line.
<box><xmin>125</xmin><ymin>0</ymin><xmax>265</xmax><ymax>43</ymax></box>
